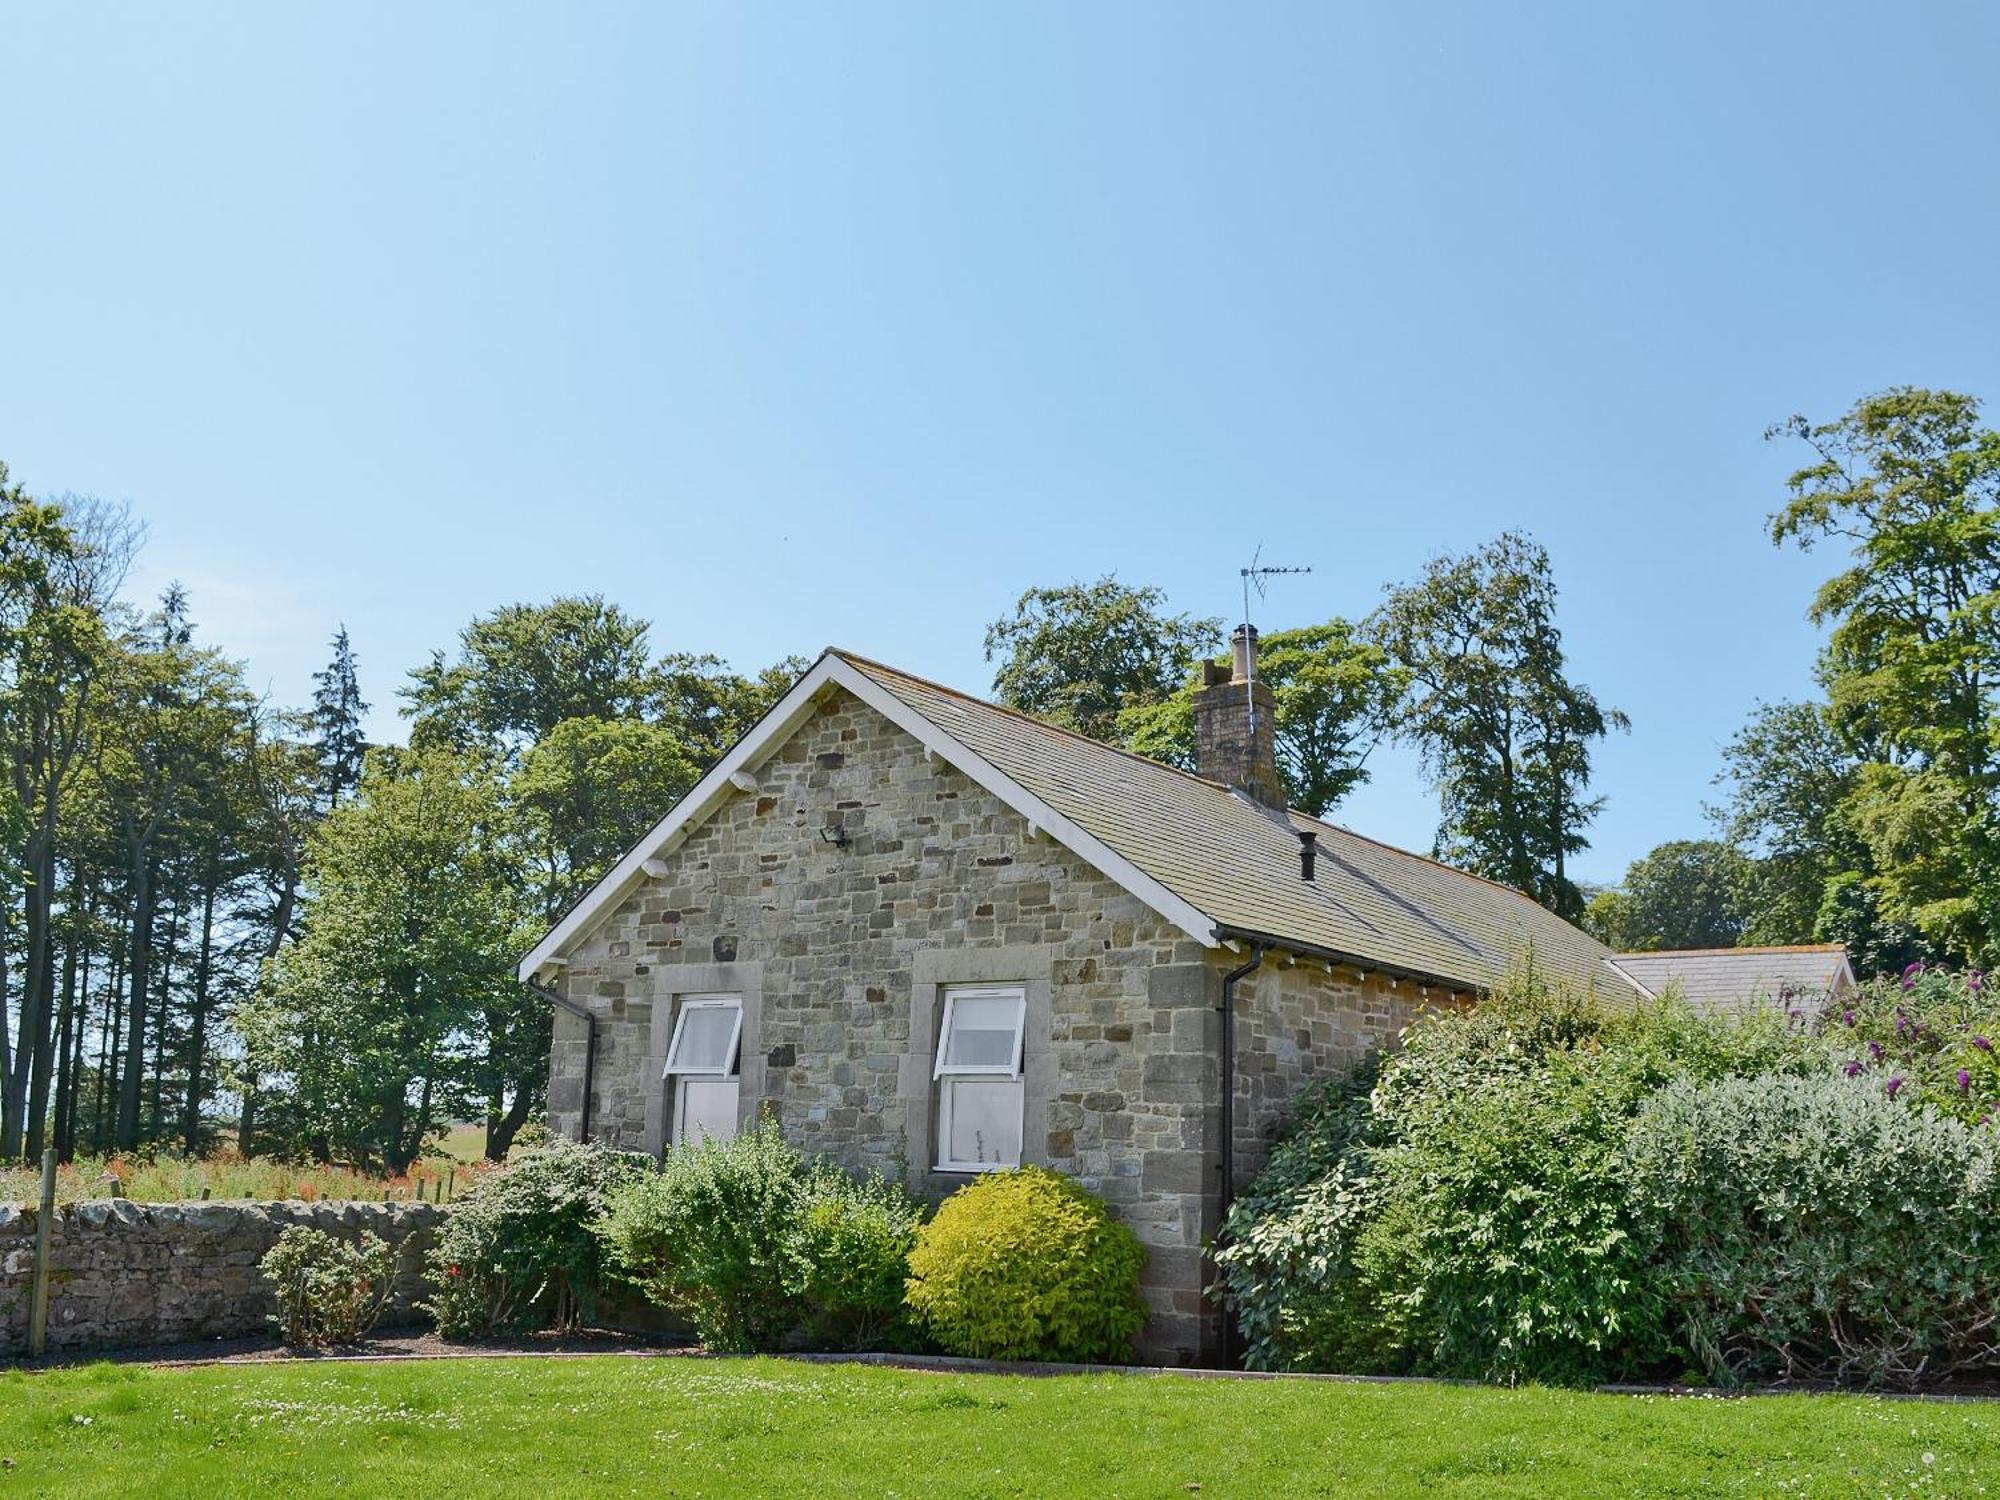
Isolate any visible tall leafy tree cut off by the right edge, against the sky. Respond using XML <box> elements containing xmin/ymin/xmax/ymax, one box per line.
<box><xmin>1770</xmin><ymin>386</ymin><xmax>2000</xmax><ymax>962</ymax></box>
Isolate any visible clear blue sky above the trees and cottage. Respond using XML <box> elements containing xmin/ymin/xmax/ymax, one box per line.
<box><xmin>0</xmin><ymin>4</ymin><xmax>2000</xmax><ymax>878</ymax></box>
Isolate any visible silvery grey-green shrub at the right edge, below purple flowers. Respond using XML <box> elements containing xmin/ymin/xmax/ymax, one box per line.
<box><xmin>1628</xmin><ymin>1076</ymin><xmax>2000</xmax><ymax>1386</ymax></box>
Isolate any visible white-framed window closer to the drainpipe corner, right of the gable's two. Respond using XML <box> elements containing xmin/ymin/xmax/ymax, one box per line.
<box><xmin>932</xmin><ymin>986</ymin><xmax>1028</xmax><ymax>1172</ymax></box>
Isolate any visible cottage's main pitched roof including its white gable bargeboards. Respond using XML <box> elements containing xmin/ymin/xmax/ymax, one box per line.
<box><xmin>520</xmin><ymin>650</ymin><xmax>1634</xmax><ymax>994</ymax></box>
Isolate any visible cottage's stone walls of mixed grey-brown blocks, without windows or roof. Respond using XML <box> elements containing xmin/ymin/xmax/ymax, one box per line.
<box><xmin>548</xmin><ymin>688</ymin><xmax>1448</xmax><ymax>1362</ymax></box>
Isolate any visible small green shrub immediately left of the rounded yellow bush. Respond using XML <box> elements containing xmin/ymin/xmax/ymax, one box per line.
<box><xmin>784</xmin><ymin>1166</ymin><xmax>924</xmax><ymax>1350</ymax></box>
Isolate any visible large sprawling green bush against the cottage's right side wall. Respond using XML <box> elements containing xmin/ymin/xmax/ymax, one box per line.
<box><xmin>1216</xmin><ymin>976</ymin><xmax>1828</xmax><ymax>1382</ymax></box>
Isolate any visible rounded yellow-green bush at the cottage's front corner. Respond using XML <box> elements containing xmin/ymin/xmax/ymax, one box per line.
<box><xmin>908</xmin><ymin>1166</ymin><xmax>1146</xmax><ymax>1362</ymax></box>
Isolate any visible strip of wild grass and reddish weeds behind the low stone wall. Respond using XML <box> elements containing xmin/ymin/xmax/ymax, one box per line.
<box><xmin>0</xmin><ymin>1152</ymin><xmax>478</xmax><ymax>1204</ymax></box>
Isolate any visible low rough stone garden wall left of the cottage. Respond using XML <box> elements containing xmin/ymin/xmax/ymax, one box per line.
<box><xmin>0</xmin><ymin>1198</ymin><xmax>448</xmax><ymax>1354</ymax></box>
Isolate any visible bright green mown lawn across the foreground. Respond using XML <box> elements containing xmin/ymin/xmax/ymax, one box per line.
<box><xmin>0</xmin><ymin>1358</ymin><xmax>2000</xmax><ymax>1500</ymax></box>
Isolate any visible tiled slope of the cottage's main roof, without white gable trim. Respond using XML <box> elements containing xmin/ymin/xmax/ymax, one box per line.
<box><xmin>836</xmin><ymin>652</ymin><xmax>1632</xmax><ymax>998</ymax></box>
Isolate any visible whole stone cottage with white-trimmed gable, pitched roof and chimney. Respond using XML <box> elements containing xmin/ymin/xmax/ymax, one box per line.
<box><xmin>520</xmin><ymin>626</ymin><xmax>1656</xmax><ymax>1364</ymax></box>
